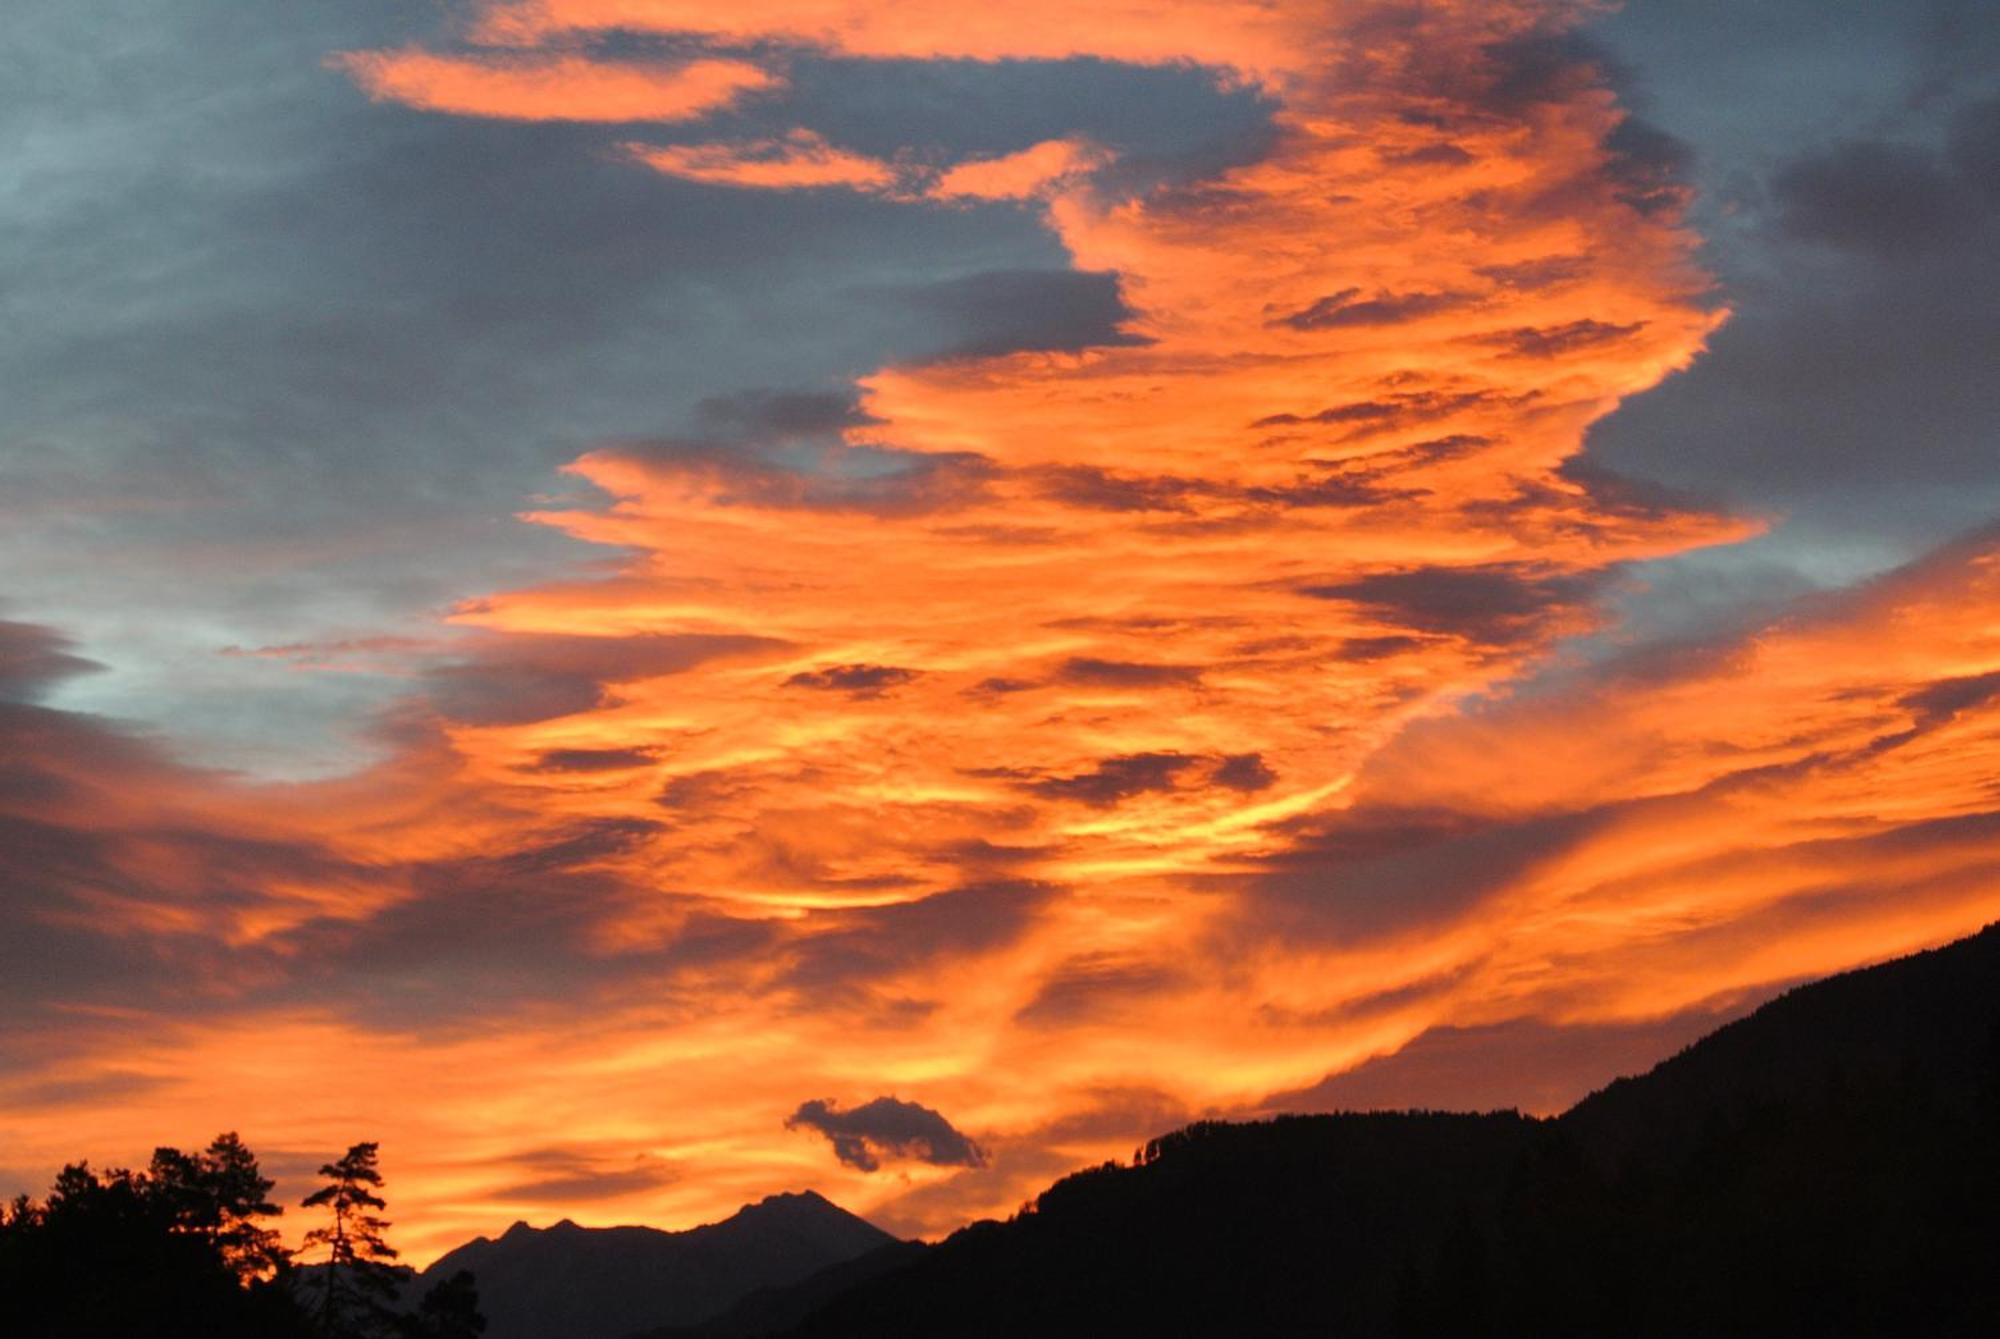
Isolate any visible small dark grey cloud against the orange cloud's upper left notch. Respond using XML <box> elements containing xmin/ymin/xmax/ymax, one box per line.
<box><xmin>884</xmin><ymin>270</ymin><xmax>1146</xmax><ymax>358</ymax></box>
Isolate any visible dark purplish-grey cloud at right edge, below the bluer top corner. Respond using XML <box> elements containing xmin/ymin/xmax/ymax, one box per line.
<box><xmin>1590</xmin><ymin>104</ymin><xmax>2000</xmax><ymax>551</ymax></box>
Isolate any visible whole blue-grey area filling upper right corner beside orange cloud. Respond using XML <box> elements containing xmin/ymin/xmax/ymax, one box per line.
<box><xmin>1590</xmin><ymin>0</ymin><xmax>2000</xmax><ymax>567</ymax></box>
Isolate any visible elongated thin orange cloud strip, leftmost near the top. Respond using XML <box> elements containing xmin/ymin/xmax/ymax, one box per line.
<box><xmin>334</xmin><ymin>48</ymin><xmax>782</xmax><ymax>122</ymax></box>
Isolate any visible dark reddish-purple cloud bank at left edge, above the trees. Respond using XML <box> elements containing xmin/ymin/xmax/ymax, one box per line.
<box><xmin>0</xmin><ymin>628</ymin><xmax>796</xmax><ymax>1031</ymax></box>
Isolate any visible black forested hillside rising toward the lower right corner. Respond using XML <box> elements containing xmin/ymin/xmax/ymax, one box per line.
<box><xmin>720</xmin><ymin>927</ymin><xmax>2000</xmax><ymax>1339</ymax></box>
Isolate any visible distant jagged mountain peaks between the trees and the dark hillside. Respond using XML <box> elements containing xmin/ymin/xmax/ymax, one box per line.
<box><xmin>430</xmin><ymin>1191</ymin><xmax>896</xmax><ymax>1339</ymax></box>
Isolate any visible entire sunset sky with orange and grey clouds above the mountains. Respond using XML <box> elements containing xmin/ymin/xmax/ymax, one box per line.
<box><xmin>0</xmin><ymin>0</ymin><xmax>2000</xmax><ymax>1263</ymax></box>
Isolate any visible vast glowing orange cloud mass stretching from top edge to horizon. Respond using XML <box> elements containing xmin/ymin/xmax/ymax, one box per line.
<box><xmin>0</xmin><ymin>0</ymin><xmax>2000</xmax><ymax>1261</ymax></box>
